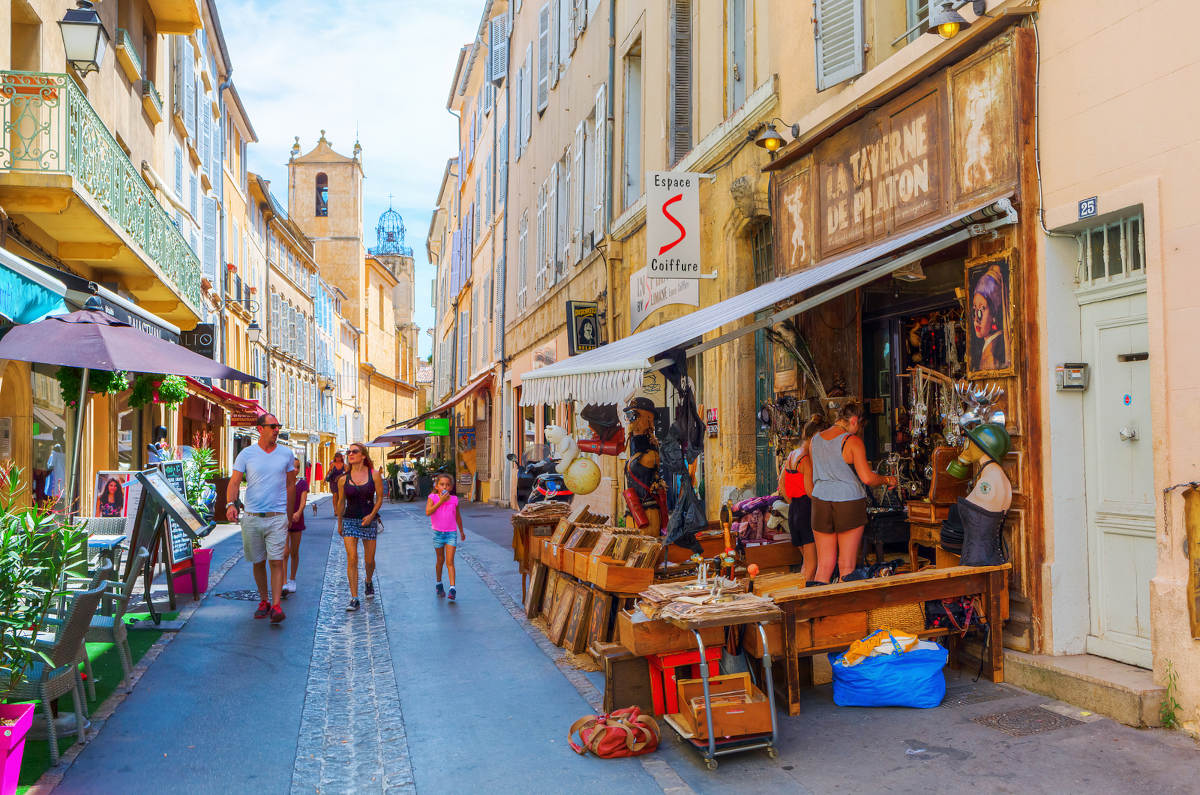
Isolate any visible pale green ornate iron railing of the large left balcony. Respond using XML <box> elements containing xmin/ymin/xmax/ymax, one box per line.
<box><xmin>0</xmin><ymin>71</ymin><xmax>202</xmax><ymax>307</ymax></box>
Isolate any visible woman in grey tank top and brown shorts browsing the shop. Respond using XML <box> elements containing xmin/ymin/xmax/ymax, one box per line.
<box><xmin>810</xmin><ymin>401</ymin><xmax>896</xmax><ymax>585</ymax></box>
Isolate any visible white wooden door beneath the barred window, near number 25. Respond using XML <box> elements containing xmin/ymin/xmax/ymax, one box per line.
<box><xmin>1080</xmin><ymin>292</ymin><xmax>1156</xmax><ymax>668</ymax></box>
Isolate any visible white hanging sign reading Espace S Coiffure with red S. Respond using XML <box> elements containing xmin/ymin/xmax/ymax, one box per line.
<box><xmin>646</xmin><ymin>172</ymin><xmax>703</xmax><ymax>279</ymax></box>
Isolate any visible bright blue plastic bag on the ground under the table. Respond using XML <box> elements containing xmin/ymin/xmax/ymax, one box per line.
<box><xmin>829</xmin><ymin>630</ymin><xmax>949</xmax><ymax>710</ymax></box>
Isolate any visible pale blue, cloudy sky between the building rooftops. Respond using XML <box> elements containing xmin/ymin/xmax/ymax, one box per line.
<box><xmin>217</xmin><ymin>0</ymin><xmax>484</xmax><ymax>357</ymax></box>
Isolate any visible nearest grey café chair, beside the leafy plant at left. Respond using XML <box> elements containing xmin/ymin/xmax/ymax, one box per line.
<box><xmin>0</xmin><ymin>585</ymin><xmax>106</xmax><ymax>765</ymax></box>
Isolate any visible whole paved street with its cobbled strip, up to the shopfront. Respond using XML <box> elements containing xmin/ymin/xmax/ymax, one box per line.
<box><xmin>44</xmin><ymin>502</ymin><xmax>1200</xmax><ymax>795</ymax></box>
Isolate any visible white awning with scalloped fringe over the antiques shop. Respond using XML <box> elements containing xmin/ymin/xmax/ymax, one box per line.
<box><xmin>521</xmin><ymin>198</ymin><xmax>1016</xmax><ymax>406</ymax></box>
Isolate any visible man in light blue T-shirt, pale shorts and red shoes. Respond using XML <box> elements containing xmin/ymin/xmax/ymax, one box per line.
<box><xmin>226</xmin><ymin>414</ymin><xmax>296</xmax><ymax>623</ymax></box>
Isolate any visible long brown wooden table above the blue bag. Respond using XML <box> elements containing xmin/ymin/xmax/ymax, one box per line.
<box><xmin>772</xmin><ymin>563</ymin><xmax>1013</xmax><ymax>715</ymax></box>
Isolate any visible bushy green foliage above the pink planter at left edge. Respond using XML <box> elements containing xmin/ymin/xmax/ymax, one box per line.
<box><xmin>0</xmin><ymin>466</ymin><xmax>88</xmax><ymax>689</ymax></box>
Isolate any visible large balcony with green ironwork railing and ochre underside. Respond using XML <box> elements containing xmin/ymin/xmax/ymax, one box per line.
<box><xmin>0</xmin><ymin>71</ymin><xmax>202</xmax><ymax>328</ymax></box>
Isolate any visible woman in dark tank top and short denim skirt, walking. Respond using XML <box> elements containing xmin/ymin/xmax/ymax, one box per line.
<box><xmin>336</xmin><ymin>442</ymin><xmax>383</xmax><ymax>612</ymax></box>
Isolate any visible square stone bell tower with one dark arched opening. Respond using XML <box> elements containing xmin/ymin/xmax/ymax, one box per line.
<box><xmin>288</xmin><ymin>130</ymin><xmax>366</xmax><ymax>328</ymax></box>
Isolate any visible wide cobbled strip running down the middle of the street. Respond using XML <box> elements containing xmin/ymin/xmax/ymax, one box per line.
<box><xmin>290</xmin><ymin>534</ymin><xmax>416</xmax><ymax>795</ymax></box>
